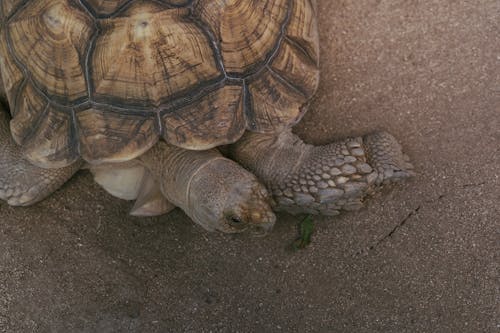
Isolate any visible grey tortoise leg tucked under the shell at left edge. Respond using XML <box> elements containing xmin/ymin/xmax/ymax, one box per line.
<box><xmin>0</xmin><ymin>104</ymin><xmax>81</xmax><ymax>206</ymax></box>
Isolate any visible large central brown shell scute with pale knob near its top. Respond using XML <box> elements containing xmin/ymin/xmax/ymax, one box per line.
<box><xmin>91</xmin><ymin>6</ymin><xmax>222</xmax><ymax>109</ymax></box>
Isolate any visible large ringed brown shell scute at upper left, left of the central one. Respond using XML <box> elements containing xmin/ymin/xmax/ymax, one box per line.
<box><xmin>6</xmin><ymin>0</ymin><xmax>94</xmax><ymax>105</ymax></box>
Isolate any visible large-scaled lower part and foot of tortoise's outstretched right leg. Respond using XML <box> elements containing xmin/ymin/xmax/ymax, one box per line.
<box><xmin>272</xmin><ymin>132</ymin><xmax>413</xmax><ymax>216</ymax></box>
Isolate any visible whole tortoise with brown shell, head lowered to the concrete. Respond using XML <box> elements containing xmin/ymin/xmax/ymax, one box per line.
<box><xmin>0</xmin><ymin>0</ymin><xmax>412</xmax><ymax>232</ymax></box>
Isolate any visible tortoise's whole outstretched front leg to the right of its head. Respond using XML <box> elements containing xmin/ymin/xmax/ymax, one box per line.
<box><xmin>230</xmin><ymin>131</ymin><xmax>413</xmax><ymax>215</ymax></box>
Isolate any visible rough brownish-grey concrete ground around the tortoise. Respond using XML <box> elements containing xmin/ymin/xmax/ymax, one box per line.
<box><xmin>0</xmin><ymin>0</ymin><xmax>500</xmax><ymax>332</ymax></box>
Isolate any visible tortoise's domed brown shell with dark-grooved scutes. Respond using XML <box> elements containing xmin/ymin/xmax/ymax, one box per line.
<box><xmin>0</xmin><ymin>0</ymin><xmax>319</xmax><ymax>168</ymax></box>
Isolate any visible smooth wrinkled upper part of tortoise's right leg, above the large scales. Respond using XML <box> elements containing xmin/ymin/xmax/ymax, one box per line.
<box><xmin>228</xmin><ymin>130</ymin><xmax>313</xmax><ymax>188</ymax></box>
